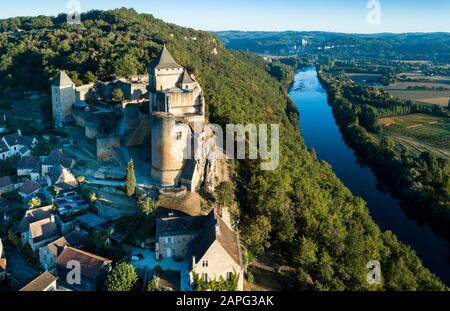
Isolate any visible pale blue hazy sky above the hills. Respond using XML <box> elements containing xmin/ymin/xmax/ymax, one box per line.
<box><xmin>0</xmin><ymin>0</ymin><xmax>450</xmax><ymax>33</ymax></box>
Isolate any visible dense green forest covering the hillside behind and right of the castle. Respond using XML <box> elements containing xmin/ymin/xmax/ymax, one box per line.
<box><xmin>0</xmin><ymin>9</ymin><xmax>447</xmax><ymax>290</ymax></box>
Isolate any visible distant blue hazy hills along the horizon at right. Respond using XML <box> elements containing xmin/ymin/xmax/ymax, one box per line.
<box><xmin>216</xmin><ymin>31</ymin><xmax>450</xmax><ymax>63</ymax></box>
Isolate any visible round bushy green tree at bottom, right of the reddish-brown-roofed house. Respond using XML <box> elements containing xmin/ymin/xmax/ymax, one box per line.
<box><xmin>105</xmin><ymin>262</ymin><xmax>138</xmax><ymax>292</ymax></box>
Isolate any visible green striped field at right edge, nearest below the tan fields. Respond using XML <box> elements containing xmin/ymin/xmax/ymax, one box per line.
<box><xmin>380</xmin><ymin>114</ymin><xmax>450</xmax><ymax>158</ymax></box>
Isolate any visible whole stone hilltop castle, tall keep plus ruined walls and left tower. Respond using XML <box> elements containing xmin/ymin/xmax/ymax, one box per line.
<box><xmin>51</xmin><ymin>46</ymin><xmax>215</xmax><ymax>191</ymax></box>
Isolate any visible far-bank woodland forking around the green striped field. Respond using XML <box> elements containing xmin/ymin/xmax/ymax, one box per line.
<box><xmin>319</xmin><ymin>71</ymin><xmax>450</xmax><ymax>234</ymax></box>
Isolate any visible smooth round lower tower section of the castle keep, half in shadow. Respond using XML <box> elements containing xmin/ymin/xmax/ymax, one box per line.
<box><xmin>152</xmin><ymin>112</ymin><xmax>190</xmax><ymax>188</ymax></box>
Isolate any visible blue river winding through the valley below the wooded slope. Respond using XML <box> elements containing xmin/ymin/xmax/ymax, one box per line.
<box><xmin>289</xmin><ymin>67</ymin><xmax>450</xmax><ymax>285</ymax></box>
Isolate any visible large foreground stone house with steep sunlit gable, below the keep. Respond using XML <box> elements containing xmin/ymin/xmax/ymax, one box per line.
<box><xmin>155</xmin><ymin>210</ymin><xmax>244</xmax><ymax>290</ymax></box>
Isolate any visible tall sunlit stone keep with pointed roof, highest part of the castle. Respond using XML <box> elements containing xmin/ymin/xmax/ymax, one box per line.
<box><xmin>148</xmin><ymin>46</ymin><xmax>209</xmax><ymax>188</ymax></box>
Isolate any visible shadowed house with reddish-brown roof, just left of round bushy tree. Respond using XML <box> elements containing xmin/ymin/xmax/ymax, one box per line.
<box><xmin>56</xmin><ymin>247</ymin><xmax>112</xmax><ymax>291</ymax></box>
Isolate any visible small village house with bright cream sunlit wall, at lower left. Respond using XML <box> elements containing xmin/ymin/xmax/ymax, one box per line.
<box><xmin>28</xmin><ymin>215</ymin><xmax>59</xmax><ymax>252</ymax></box>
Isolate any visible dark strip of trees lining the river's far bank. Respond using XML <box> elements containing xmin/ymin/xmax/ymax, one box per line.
<box><xmin>318</xmin><ymin>71</ymin><xmax>450</xmax><ymax>236</ymax></box>
